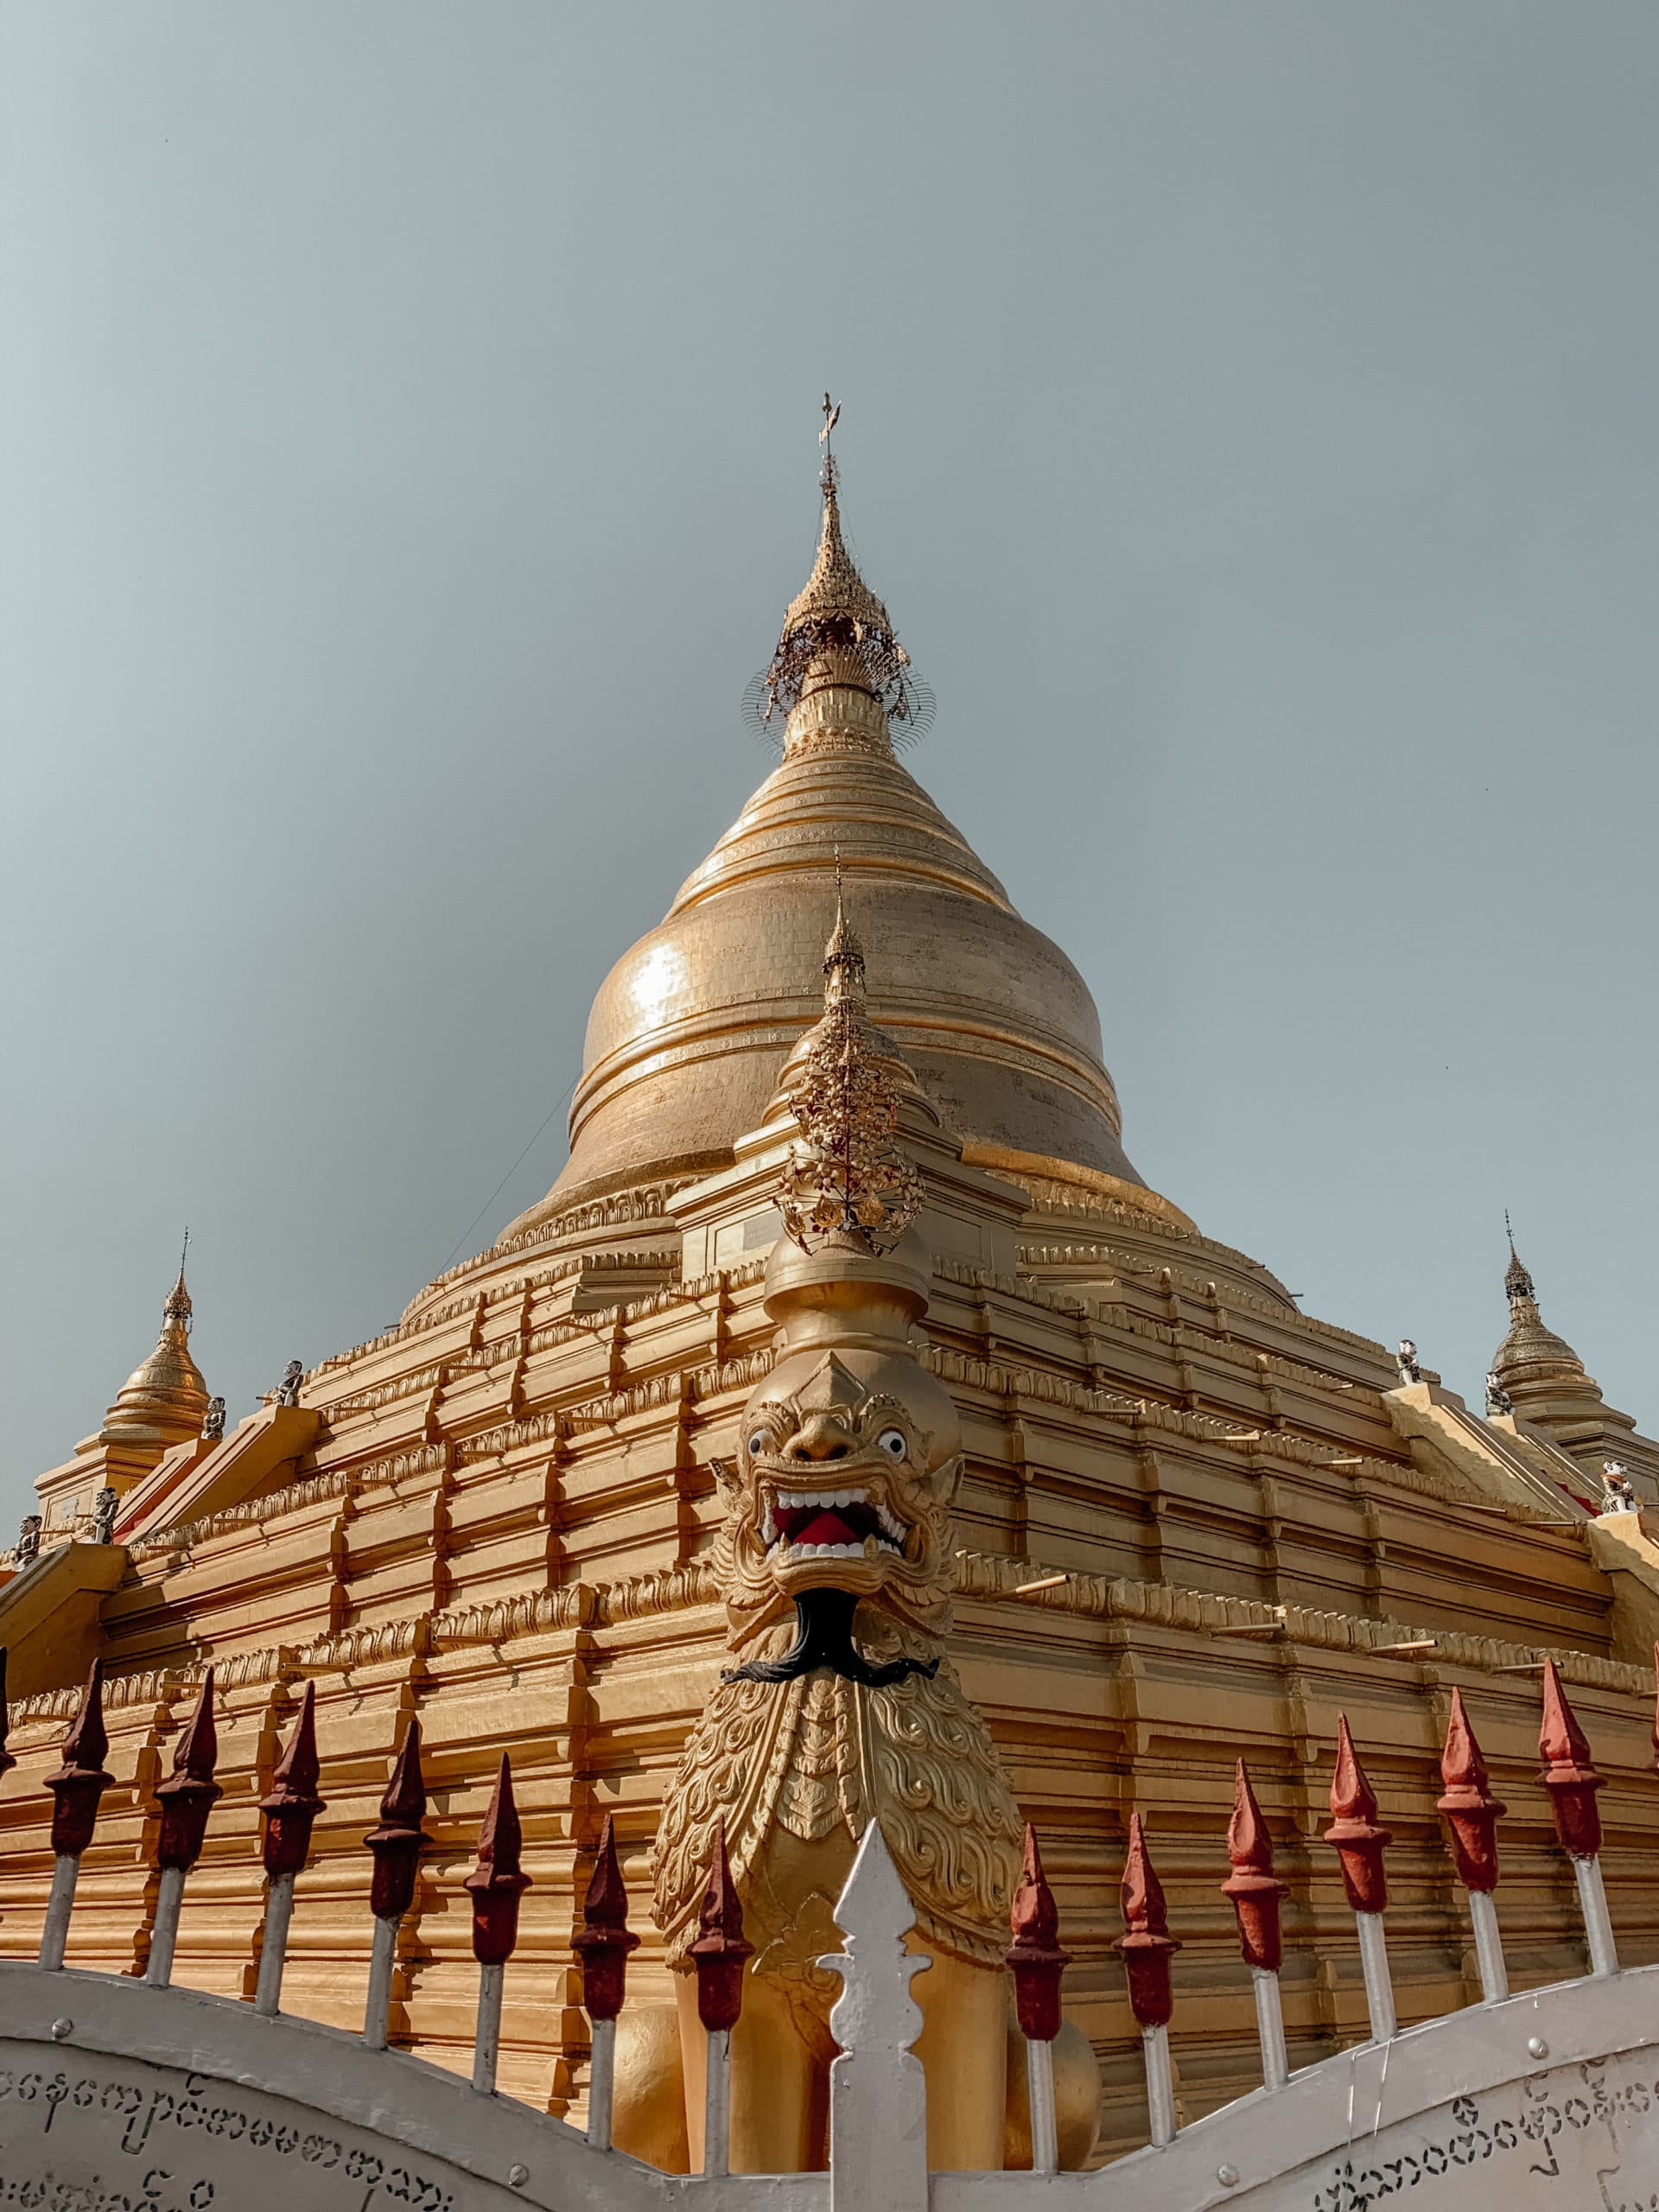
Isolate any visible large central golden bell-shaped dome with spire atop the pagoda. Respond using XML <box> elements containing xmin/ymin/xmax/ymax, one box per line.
<box><xmin>506</xmin><ymin>451</ymin><xmax>1173</xmax><ymax>1239</ymax></box>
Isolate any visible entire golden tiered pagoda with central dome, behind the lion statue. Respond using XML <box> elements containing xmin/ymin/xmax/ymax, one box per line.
<box><xmin>0</xmin><ymin>417</ymin><xmax>1659</xmax><ymax>2168</ymax></box>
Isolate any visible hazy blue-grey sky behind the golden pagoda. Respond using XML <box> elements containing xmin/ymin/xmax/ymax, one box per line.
<box><xmin>0</xmin><ymin>0</ymin><xmax>1659</xmax><ymax>1529</ymax></box>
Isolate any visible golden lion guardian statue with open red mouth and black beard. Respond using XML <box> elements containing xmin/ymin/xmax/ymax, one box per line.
<box><xmin>617</xmin><ymin>1232</ymin><xmax>1097</xmax><ymax>2172</ymax></box>
